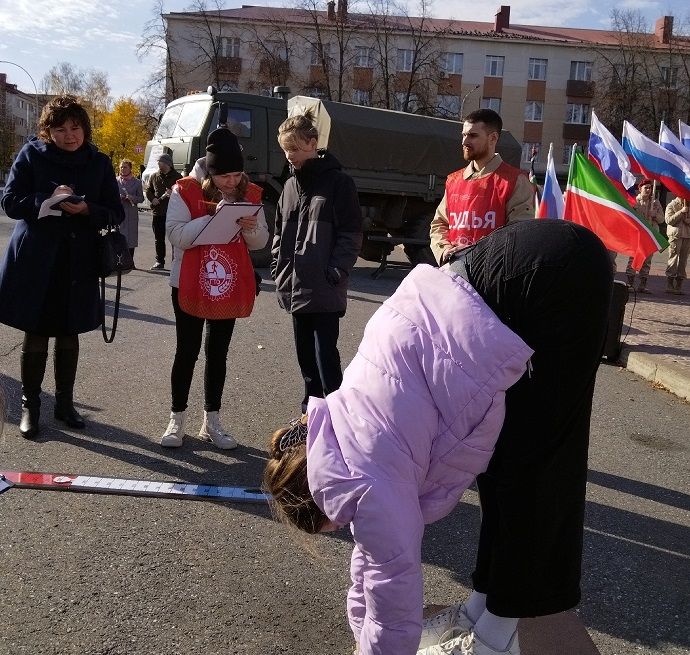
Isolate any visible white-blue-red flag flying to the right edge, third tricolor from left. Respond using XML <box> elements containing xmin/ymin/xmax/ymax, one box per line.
<box><xmin>623</xmin><ymin>121</ymin><xmax>690</xmax><ymax>200</ymax></box>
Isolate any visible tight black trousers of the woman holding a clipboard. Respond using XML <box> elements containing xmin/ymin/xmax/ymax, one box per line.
<box><xmin>170</xmin><ymin>287</ymin><xmax>235</xmax><ymax>412</ymax></box>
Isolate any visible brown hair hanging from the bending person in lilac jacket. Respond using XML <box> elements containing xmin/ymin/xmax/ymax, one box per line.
<box><xmin>263</xmin><ymin>428</ymin><xmax>328</xmax><ymax>534</ymax></box>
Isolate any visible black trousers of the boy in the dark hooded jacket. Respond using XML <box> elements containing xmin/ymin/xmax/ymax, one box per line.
<box><xmin>292</xmin><ymin>312</ymin><xmax>343</xmax><ymax>412</ymax></box>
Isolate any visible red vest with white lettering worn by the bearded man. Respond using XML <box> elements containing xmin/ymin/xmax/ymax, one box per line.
<box><xmin>446</xmin><ymin>162</ymin><xmax>522</xmax><ymax>248</ymax></box>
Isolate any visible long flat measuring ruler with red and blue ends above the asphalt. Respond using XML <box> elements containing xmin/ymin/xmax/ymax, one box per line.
<box><xmin>0</xmin><ymin>471</ymin><xmax>269</xmax><ymax>503</ymax></box>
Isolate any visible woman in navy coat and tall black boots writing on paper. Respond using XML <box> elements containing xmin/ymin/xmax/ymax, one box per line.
<box><xmin>0</xmin><ymin>96</ymin><xmax>124</xmax><ymax>438</ymax></box>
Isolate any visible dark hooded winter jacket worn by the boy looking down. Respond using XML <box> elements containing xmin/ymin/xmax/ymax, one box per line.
<box><xmin>271</xmin><ymin>151</ymin><xmax>362</xmax><ymax>314</ymax></box>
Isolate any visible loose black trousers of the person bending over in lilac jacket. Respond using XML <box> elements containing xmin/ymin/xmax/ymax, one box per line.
<box><xmin>451</xmin><ymin>220</ymin><xmax>612</xmax><ymax>617</ymax></box>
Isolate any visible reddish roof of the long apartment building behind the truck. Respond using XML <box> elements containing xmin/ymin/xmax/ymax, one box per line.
<box><xmin>165</xmin><ymin>3</ymin><xmax>690</xmax><ymax>48</ymax></box>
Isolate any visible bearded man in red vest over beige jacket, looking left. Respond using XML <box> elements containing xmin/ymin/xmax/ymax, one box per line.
<box><xmin>430</xmin><ymin>109</ymin><xmax>534</xmax><ymax>265</ymax></box>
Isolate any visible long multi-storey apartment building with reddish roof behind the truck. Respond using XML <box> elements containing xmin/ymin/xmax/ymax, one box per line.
<box><xmin>165</xmin><ymin>0</ymin><xmax>690</xmax><ymax>173</ymax></box>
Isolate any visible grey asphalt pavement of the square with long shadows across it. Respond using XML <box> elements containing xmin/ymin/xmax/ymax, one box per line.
<box><xmin>0</xmin><ymin>213</ymin><xmax>690</xmax><ymax>655</ymax></box>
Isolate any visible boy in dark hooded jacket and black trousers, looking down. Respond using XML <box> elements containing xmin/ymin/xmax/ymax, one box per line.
<box><xmin>271</xmin><ymin>113</ymin><xmax>362</xmax><ymax>412</ymax></box>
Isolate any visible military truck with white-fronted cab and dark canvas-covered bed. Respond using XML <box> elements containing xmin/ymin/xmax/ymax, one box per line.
<box><xmin>143</xmin><ymin>88</ymin><xmax>521</xmax><ymax>272</ymax></box>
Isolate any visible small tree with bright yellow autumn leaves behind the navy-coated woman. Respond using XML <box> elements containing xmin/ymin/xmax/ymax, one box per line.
<box><xmin>93</xmin><ymin>98</ymin><xmax>151</xmax><ymax>175</ymax></box>
